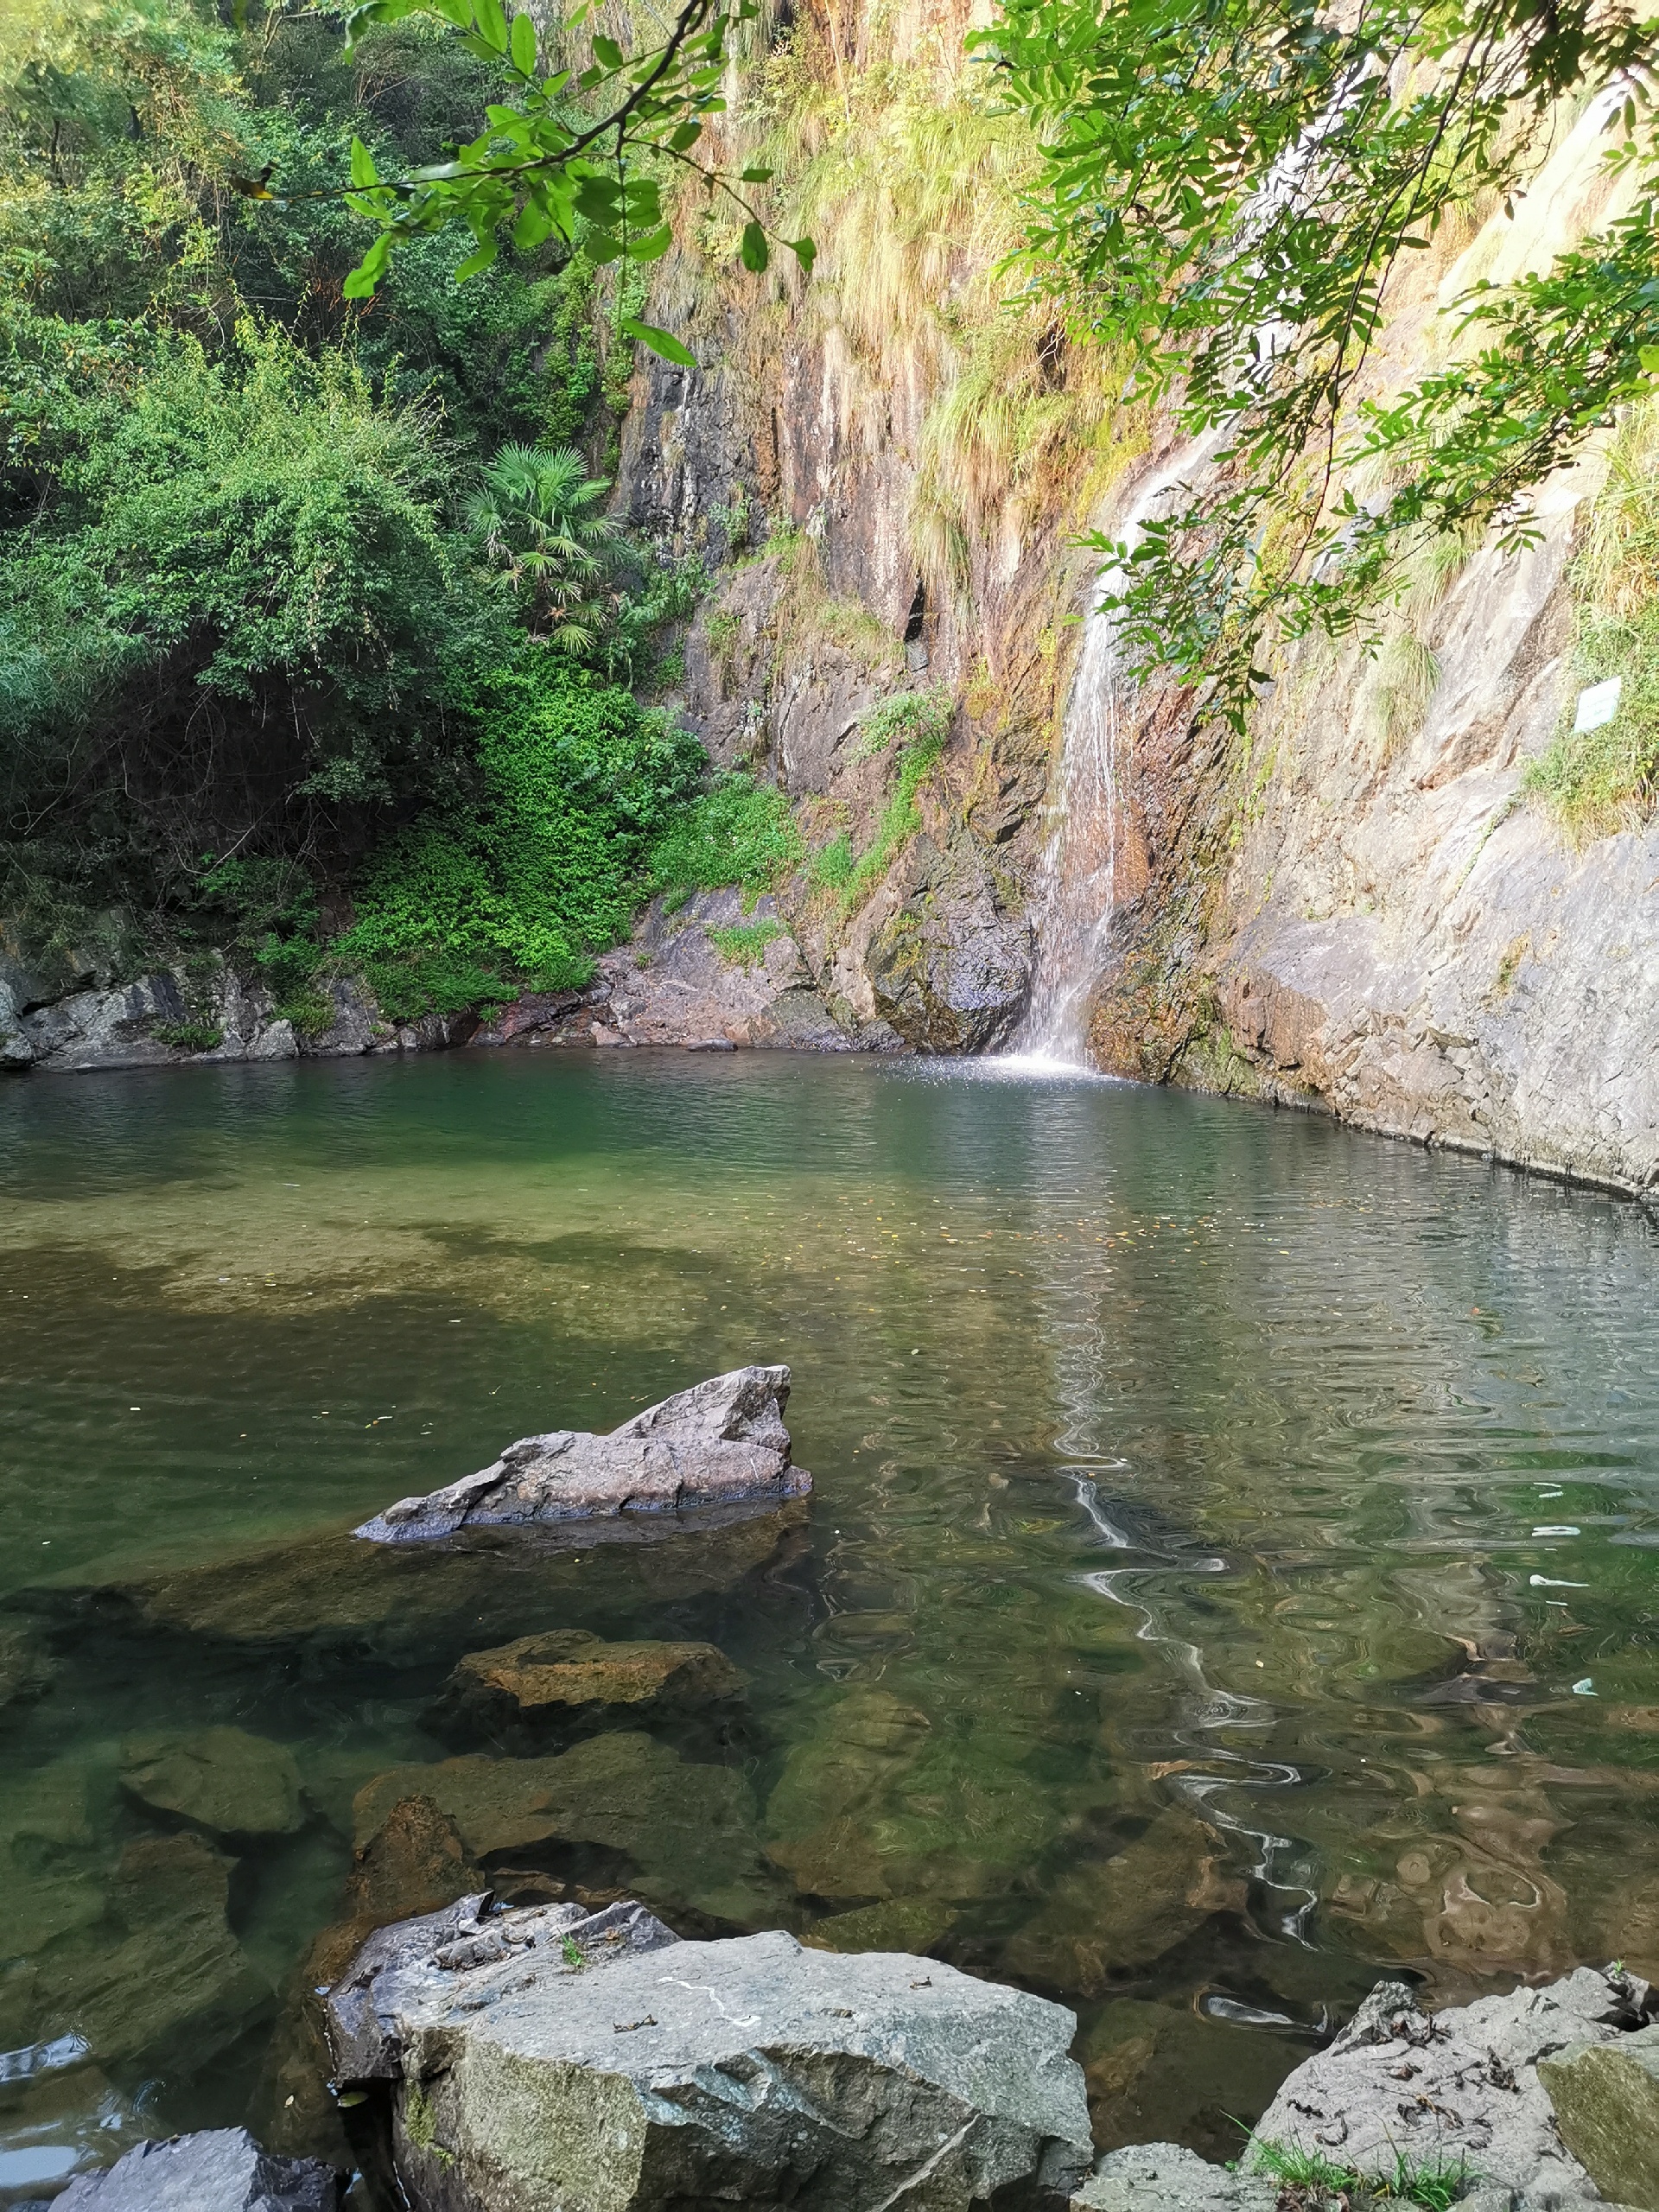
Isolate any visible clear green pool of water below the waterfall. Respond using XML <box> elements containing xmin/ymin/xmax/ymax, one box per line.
<box><xmin>0</xmin><ymin>1053</ymin><xmax>1659</xmax><ymax>2203</ymax></box>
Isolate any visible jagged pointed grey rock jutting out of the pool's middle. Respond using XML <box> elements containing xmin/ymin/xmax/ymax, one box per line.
<box><xmin>356</xmin><ymin>1367</ymin><xmax>812</xmax><ymax>1544</ymax></box>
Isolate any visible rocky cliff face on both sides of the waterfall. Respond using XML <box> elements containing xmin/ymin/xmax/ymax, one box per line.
<box><xmin>624</xmin><ymin>7</ymin><xmax>1659</xmax><ymax>1190</ymax></box>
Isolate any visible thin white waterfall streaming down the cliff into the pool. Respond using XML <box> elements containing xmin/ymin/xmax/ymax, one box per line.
<box><xmin>1008</xmin><ymin>431</ymin><xmax>1221</xmax><ymax>1075</ymax></box>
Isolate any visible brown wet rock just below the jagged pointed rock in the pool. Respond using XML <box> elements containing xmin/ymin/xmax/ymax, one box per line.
<box><xmin>434</xmin><ymin>1628</ymin><xmax>746</xmax><ymax>1737</ymax></box>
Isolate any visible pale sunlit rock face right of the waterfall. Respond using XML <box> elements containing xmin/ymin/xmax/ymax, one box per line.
<box><xmin>1090</xmin><ymin>108</ymin><xmax>1659</xmax><ymax>1192</ymax></box>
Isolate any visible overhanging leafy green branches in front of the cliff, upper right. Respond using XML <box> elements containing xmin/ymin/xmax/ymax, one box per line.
<box><xmin>980</xmin><ymin>0</ymin><xmax>1659</xmax><ymax>723</ymax></box>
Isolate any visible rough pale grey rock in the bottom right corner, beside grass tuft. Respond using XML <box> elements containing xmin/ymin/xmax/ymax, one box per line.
<box><xmin>1256</xmin><ymin>1967</ymin><xmax>1650</xmax><ymax>2199</ymax></box>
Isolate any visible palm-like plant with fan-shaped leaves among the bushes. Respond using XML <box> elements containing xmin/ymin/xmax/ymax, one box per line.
<box><xmin>467</xmin><ymin>445</ymin><xmax>621</xmax><ymax>652</ymax></box>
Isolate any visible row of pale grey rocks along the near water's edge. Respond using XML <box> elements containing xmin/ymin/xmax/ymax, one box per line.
<box><xmin>60</xmin><ymin>1955</ymin><xmax>1659</xmax><ymax>2212</ymax></box>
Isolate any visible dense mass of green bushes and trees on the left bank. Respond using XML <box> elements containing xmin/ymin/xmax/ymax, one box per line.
<box><xmin>0</xmin><ymin>0</ymin><xmax>777</xmax><ymax>1004</ymax></box>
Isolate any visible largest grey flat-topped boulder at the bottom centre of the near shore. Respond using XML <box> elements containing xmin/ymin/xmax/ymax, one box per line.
<box><xmin>327</xmin><ymin>1897</ymin><xmax>1093</xmax><ymax>2212</ymax></box>
